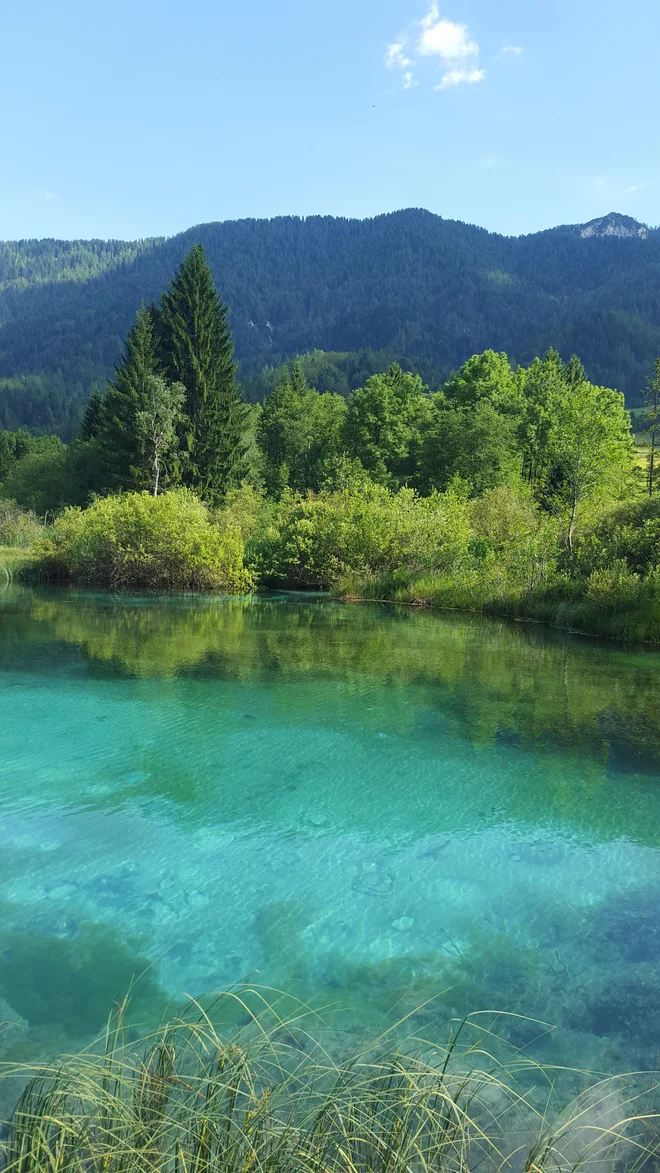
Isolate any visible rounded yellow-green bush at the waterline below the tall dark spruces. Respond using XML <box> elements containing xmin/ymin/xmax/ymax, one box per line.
<box><xmin>36</xmin><ymin>489</ymin><xmax>253</xmax><ymax>592</ymax></box>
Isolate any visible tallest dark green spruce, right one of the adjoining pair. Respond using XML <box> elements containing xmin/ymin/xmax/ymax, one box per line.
<box><xmin>157</xmin><ymin>244</ymin><xmax>250</xmax><ymax>502</ymax></box>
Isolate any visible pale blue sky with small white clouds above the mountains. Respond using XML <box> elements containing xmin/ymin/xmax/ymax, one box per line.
<box><xmin>0</xmin><ymin>0</ymin><xmax>660</xmax><ymax>239</ymax></box>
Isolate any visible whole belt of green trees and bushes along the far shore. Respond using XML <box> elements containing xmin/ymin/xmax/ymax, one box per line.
<box><xmin>0</xmin><ymin>238</ymin><xmax>660</xmax><ymax>643</ymax></box>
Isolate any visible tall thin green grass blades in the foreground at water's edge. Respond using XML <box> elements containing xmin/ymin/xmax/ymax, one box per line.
<box><xmin>0</xmin><ymin>990</ymin><xmax>658</xmax><ymax>1173</ymax></box>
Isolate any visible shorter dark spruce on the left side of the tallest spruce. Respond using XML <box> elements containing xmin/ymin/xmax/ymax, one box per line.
<box><xmin>97</xmin><ymin>305</ymin><xmax>161</xmax><ymax>489</ymax></box>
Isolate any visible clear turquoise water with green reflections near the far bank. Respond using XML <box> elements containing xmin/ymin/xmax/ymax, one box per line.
<box><xmin>0</xmin><ymin>589</ymin><xmax>660</xmax><ymax>1071</ymax></box>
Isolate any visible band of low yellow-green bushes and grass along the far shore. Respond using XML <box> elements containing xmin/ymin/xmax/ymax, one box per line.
<box><xmin>6</xmin><ymin>482</ymin><xmax>660</xmax><ymax>644</ymax></box>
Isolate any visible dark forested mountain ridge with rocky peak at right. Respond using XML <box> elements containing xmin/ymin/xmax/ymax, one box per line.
<box><xmin>0</xmin><ymin>209</ymin><xmax>660</xmax><ymax>435</ymax></box>
